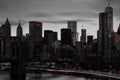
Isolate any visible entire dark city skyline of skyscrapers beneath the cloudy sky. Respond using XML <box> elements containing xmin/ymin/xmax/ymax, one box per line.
<box><xmin>0</xmin><ymin>0</ymin><xmax>120</xmax><ymax>70</ymax></box>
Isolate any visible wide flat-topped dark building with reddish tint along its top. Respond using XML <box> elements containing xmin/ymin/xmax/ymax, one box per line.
<box><xmin>29</xmin><ymin>21</ymin><xmax>42</xmax><ymax>41</ymax></box>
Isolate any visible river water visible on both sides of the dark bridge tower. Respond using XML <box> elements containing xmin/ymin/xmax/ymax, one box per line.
<box><xmin>0</xmin><ymin>72</ymin><xmax>86</xmax><ymax>80</ymax></box>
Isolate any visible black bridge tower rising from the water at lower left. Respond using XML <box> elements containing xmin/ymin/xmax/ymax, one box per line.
<box><xmin>10</xmin><ymin>41</ymin><xmax>26</xmax><ymax>80</ymax></box>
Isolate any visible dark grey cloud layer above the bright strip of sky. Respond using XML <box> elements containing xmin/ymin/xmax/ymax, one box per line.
<box><xmin>0</xmin><ymin>0</ymin><xmax>120</xmax><ymax>23</ymax></box>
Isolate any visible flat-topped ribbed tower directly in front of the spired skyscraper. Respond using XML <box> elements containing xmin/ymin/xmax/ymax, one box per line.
<box><xmin>98</xmin><ymin>12</ymin><xmax>109</xmax><ymax>56</ymax></box>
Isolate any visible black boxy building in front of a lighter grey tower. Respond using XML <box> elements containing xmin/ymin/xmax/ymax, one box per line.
<box><xmin>61</xmin><ymin>28</ymin><xmax>72</xmax><ymax>45</ymax></box>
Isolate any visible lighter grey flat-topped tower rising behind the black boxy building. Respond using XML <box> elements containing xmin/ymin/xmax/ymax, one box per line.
<box><xmin>68</xmin><ymin>21</ymin><xmax>78</xmax><ymax>45</ymax></box>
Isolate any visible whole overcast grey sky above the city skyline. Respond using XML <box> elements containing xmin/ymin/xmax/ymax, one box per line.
<box><xmin>0</xmin><ymin>0</ymin><xmax>120</xmax><ymax>39</ymax></box>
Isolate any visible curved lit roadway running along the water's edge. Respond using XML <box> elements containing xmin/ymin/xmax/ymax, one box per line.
<box><xmin>27</xmin><ymin>68</ymin><xmax>120</xmax><ymax>80</ymax></box>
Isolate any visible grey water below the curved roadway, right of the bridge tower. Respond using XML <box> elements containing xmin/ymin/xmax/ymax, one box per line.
<box><xmin>27</xmin><ymin>73</ymin><xmax>86</xmax><ymax>80</ymax></box>
